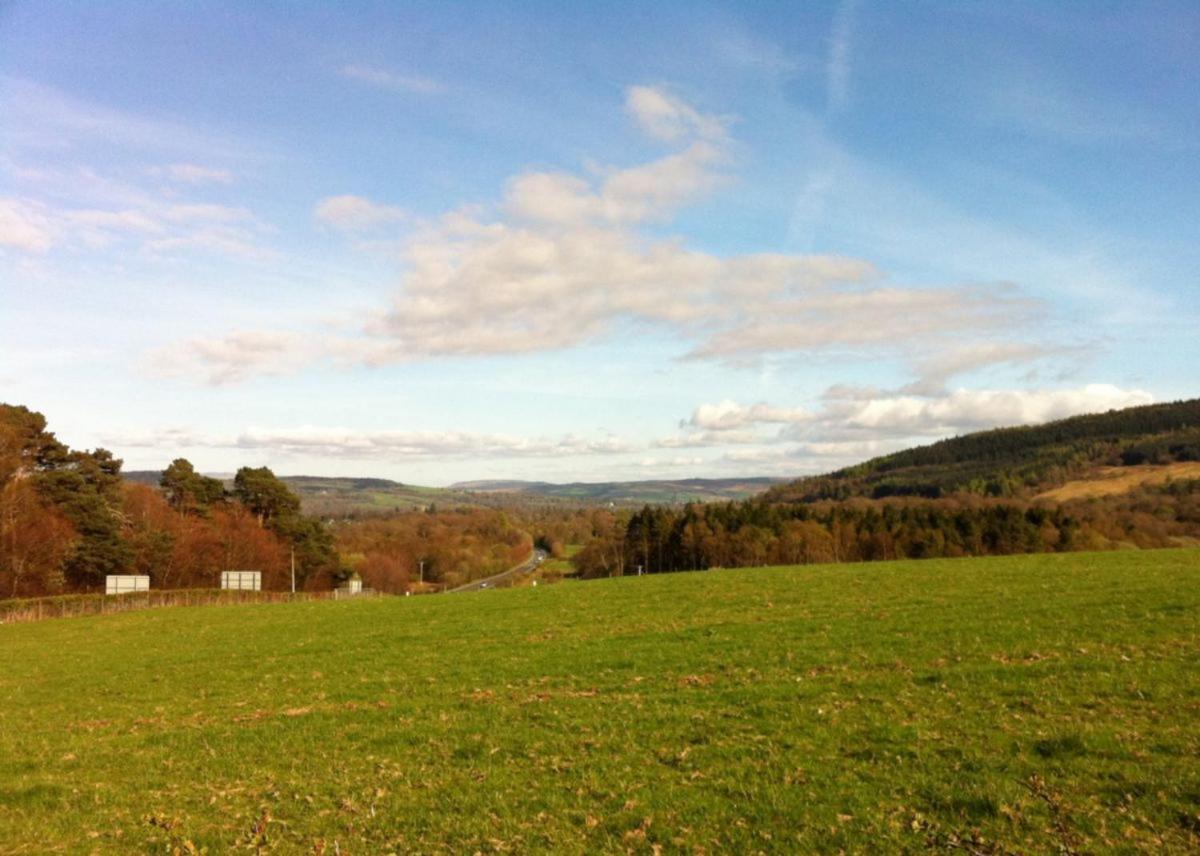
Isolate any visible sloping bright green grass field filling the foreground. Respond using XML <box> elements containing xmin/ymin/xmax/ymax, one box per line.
<box><xmin>0</xmin><ymin>550</ymin><xmax>1200</xmax><ymax>854</ymax></box>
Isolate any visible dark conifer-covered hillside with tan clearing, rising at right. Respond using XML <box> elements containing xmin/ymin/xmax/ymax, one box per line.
<box><xmin>763</xmin><ymin>399</ymin><xmax>1200</xmax><ymax>502</ymax></box>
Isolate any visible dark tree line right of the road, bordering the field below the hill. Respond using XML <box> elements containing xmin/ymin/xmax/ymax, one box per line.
<box><xmin>572</xmin><ymin>480</ymin><xmax>1200</xmax><ymax>577</ymax></box>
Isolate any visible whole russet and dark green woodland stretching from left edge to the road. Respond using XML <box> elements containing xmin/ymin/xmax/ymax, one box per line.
<box><xmin>0</xmin><ymin>403</ymin><xmax>549</xmax><ymax>599</ymax></box>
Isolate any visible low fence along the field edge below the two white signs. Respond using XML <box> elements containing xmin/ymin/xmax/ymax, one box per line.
<box><xmin>0</xmin><ymin>588</ymin><xmax>335</xmax><ymax>624</ymax></box>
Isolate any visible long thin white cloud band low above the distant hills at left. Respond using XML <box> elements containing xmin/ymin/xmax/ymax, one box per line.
<box><xmin>103</xmin><ymin>426</ymin><xmax>632</xmax><ymax>460</ymax></box>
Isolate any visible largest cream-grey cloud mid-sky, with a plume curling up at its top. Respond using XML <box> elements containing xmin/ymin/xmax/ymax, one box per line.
<box><xmin>154</xmin><ymin>86</ymin><xmax>1037</xmax><ymax>375</ymax></box>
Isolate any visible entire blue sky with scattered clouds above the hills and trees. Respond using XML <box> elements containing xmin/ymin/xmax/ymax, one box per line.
<box><xmin>0</xmin><ymin>0</ymin><xmax>1200</xmax><ymax>485</ymax></box>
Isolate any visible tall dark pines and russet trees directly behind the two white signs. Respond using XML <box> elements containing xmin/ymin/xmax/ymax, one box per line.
<box><xmin>0</xmin><ymin>405</ymin><xmax>338</xmax><ymax>597</ymax></box>
